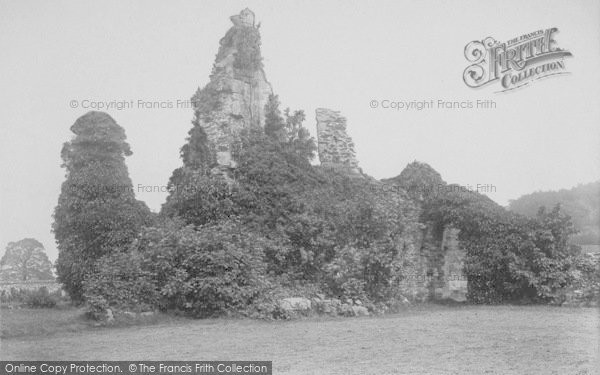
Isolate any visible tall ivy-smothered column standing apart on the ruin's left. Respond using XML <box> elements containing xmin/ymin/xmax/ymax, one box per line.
<box><xmin>52</xmin><ymin>112</ymin><xmax>151</xmax><ymax>301</ymax></box>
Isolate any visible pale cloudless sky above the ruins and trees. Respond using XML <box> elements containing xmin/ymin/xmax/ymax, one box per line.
<box><xmin>0</xmin><ymin>0</ymin><xmax>600</xmax><ymax>260</ymax></box>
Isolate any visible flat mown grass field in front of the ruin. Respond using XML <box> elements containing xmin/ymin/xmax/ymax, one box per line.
<box><xmin>0</xmin><ymin>306</ymin><xmax>600</xmax><ymax>375</ymax></box>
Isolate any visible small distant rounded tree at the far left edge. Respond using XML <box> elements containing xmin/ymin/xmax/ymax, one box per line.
<box><xmin>0</xmin><ymin>238</ymin><xmax>54</xmax><ymax>281</ymax></box>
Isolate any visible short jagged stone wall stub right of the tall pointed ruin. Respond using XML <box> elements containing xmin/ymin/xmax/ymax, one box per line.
<box><xmin>316</xmin><ymin>108</ymin><xmax>359</xmax><ymax>173</ymax></box>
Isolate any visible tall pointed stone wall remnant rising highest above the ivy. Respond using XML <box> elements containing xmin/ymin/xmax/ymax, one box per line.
<box><xmin>192</xmin><ymin>9</ymin><xmax>273</xmax><ymax>167</ymax></box>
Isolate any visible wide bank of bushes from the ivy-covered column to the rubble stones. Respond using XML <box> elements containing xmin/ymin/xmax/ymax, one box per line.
<box><xmin>84</xmin><ymin>221</ymin><xmax>276</xmax><ymax>317</ymax></box>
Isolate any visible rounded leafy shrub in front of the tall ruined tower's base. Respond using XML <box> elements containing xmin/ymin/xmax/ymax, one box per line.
<box><xmin>138</xmin><ymin>221</ymin><xmax>270</xmax><ymax>317</ymax></box>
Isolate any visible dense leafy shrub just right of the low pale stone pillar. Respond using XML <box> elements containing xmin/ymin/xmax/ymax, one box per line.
<box><xmin>463</xmin><ymin>207</ymin><xmax>578</xmax><ymax>303</ymax></box>
